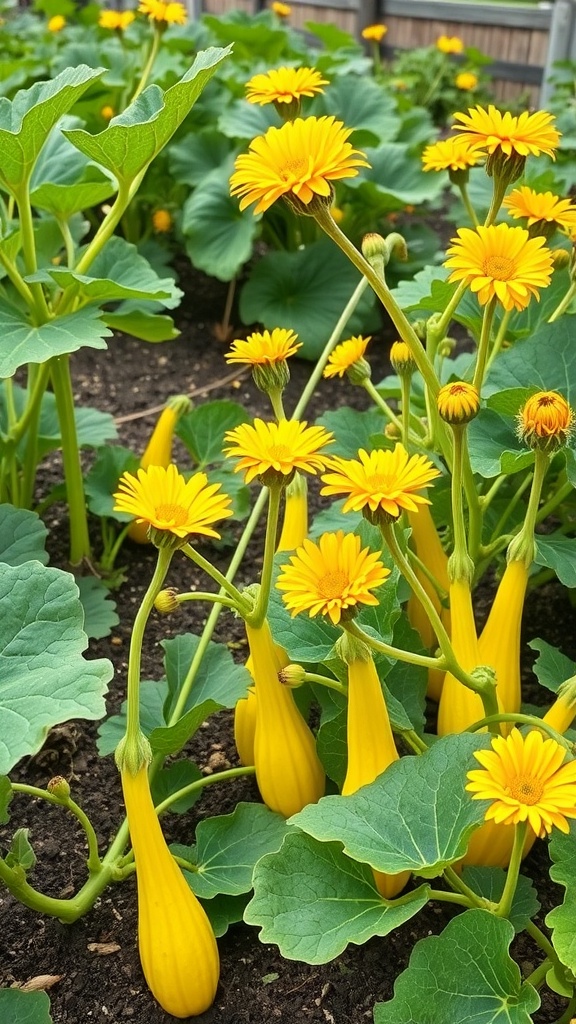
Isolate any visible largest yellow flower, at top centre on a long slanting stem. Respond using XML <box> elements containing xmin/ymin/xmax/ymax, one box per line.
<box><xmin>230</xmin><ymin>117</ymin><xmax>368</xmax><ymax>213</ymax></box>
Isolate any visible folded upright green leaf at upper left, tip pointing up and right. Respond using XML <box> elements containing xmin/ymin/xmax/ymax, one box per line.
<box><xmin>65</xmin><ymin>47</ymin><xmax>231</xmax><ymax>186</ymax></box>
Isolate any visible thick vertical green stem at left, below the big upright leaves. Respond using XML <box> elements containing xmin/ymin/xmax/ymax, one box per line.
<box><xmin>49</xmin><ymin>354</ymin><xmax>91</xmax><ymax>565</ymax></box>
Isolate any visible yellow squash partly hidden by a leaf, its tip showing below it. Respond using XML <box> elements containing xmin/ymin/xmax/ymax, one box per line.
<box><xmin>342</xmin><ymin>658</ymin><xmax>410</xmax><ymax>899</ymax></box>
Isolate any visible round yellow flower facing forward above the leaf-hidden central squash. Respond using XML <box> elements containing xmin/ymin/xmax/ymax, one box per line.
<box><xmin>276</xmin><ymin>529</ymin><xmax>389</xmax><ymax>624</ymax></box>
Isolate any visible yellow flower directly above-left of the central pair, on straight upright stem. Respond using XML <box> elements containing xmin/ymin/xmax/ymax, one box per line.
<box><xmin>224</xmin><ymin>419</ymin><xmax>333</xmax><ymax>484</ymax></box>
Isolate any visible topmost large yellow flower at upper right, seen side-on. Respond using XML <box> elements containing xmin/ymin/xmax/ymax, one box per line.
<box><xmin>453</xmin><ymin>103</ymin><xmax>560</xmax><ymax>160</ymax></box>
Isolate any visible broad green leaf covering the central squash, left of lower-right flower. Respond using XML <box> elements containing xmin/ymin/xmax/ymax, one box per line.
<box><xmin>290</xmin><ymin>734</ymin><xmax>488</xmax><ymax>878</ymax></box>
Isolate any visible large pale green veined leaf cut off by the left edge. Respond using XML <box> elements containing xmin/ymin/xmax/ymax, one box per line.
<box><xmin>0</xmin><ymin>561</ymin><xmax>114</xmax><ymax>772</ymax></box>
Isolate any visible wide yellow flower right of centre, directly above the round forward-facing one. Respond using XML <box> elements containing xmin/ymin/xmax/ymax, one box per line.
<box><xmin>321</xmin><ymin>443</ymin><xmax>440</xmax><ymax>519</ymax></box>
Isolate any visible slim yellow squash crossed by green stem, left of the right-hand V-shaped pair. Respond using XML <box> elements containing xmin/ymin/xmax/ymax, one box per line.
<box><xmin>438</xmin><ymin>580</ymin><xmax>484</xmax><ymax>736</ymax></box>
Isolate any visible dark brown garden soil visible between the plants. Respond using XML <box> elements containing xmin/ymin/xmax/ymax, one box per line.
<box><xmin>0</xmin><ymin>270</ymin><xmax>576</xmax><ymax>1024</ymax></box>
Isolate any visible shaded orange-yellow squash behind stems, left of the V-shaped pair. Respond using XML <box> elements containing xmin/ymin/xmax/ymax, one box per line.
<box><xmin>407</xmin><ymin>505</ymin><xmax>450</xmax><ymax>700</ymax></box>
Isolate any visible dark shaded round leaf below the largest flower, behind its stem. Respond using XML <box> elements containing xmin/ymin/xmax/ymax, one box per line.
<box><xmin>240</xmin><ymin>239</ymin><xmax>374</xmax><ymax>359</ymax></box>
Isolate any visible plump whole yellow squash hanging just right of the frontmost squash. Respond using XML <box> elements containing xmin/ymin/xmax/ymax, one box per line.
<box><xmin>246</xmin><ymin>622</ymin><xmax>326</xmax><ymax>817</ymax></box>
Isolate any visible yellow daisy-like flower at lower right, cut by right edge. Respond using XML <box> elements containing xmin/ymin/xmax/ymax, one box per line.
<box><xmin>466</xmin><ymin>728</ymin><xmax>576</xmax><ymax>837</ymax></box>
